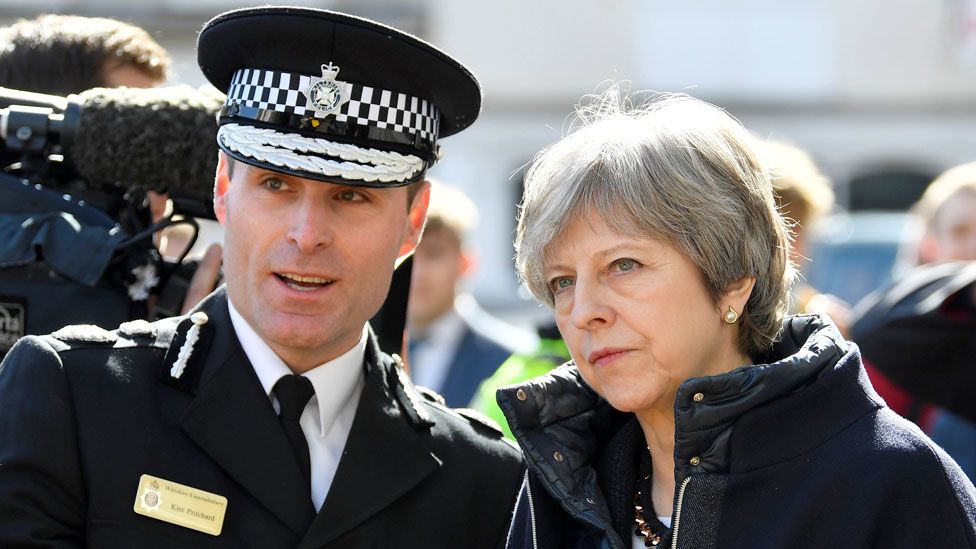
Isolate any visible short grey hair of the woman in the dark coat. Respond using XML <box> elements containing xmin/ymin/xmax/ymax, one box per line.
<box><xmin>515</xmin><ymin>87</ymin><xmax>794</xmax><ymax>357</ymax></box>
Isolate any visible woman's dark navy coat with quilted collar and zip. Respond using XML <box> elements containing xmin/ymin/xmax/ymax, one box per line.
<box><xmin>498</xmin><ymin>316</ymin><xmax>976</xmax><ymax>549</ymax></box>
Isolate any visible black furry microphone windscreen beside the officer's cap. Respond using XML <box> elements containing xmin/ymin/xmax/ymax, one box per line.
<box><xmin>68</xmin><ymin>86</ymin><xmax>224</xmax><ymax>213</ymax></box>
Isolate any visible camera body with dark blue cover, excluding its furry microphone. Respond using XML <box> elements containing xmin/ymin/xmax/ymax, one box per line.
<box><xmin>0</xmin><ymin>89</ymin><xmax>210</xmax><ymax>359</ymax></box>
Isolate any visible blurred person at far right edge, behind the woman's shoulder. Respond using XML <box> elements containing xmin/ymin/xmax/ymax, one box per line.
<box><xmin>855</xmin><ymin>162</ymin><xmax>976</xmax><ymax>479</ymax></box>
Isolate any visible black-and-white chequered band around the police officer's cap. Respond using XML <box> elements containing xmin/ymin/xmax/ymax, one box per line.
<box><xmin>227</xmin><ymin>69</ymin><xmax>440</xmax><ymax>143</ymax></box>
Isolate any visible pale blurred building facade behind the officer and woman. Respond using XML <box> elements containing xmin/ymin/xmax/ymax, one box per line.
<box><xmin>7</xmin><ymin>0</ymin><xmax>976</xmax><ymax>322</ymax></box>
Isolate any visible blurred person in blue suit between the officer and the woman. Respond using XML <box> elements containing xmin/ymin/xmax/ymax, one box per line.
<box><xmin>407</xmin><ymin>181</ymin><xmax>535</xmax><ymax>406</ymax></box>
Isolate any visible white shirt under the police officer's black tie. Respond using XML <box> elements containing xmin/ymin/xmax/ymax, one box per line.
<box><xmin>227</xmin><ymin>300</ymin><xmax>368</xmax><ymax>511</ymax></box>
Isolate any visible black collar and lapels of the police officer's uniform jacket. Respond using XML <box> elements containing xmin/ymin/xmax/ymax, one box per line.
<box><xmin>160</xmin><ymin>288</ymin><xmax>441</xmax><ymax>547</ymax></box>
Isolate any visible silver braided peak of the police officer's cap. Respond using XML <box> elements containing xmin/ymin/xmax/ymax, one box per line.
<box><xmin>217</xmin><ymin>124</ymin><xmax>425</xmax><ymax>183</ymax></box>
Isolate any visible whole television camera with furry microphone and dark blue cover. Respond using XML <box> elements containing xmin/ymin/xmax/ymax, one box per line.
<box><xmin>0</xmin><ymin>86</ymin><xmax>223</xmax><ymax>358</ymax></box>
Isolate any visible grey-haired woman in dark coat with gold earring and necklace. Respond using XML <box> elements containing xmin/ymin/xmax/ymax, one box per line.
<box><xmin>498</xmin><ymin>89</ymin><xmax>976</xmax><ymax>549</ymax></box>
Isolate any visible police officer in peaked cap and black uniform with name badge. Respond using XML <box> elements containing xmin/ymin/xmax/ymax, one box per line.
<box><xmin>0</xmin><ymin>7</ymin><xmax>522</xmax><ymax>548</ymax></box>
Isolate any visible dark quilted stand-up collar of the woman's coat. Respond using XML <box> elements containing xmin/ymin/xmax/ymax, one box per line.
<box><xmin>498</xmin><ymin>316</ymin><xmax>881</xmax><ymax>509</ymax></box>
